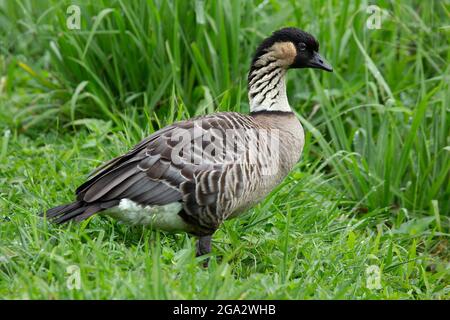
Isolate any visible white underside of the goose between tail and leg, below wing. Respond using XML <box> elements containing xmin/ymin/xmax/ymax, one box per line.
<box><xmin>104</xmin><ymin>199</ymin><xmax>190</xmax><ymax>232</ymax></box>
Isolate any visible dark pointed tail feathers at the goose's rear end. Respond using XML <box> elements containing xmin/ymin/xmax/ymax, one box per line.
<box><xmin>42</xmin><ymin>200</ymin><xmax>105</xmax><ymax>224</ymax></box>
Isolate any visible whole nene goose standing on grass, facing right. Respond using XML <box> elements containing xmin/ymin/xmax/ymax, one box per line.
<box><xmin>46</xmin><ymin>28</ymin><xmax>332</xmax><ymax>256</ymax></box>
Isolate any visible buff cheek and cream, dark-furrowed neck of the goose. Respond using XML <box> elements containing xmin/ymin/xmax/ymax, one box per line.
<box><xmin>248</xmin><ymin>42</ymin><xmax>296</xmax><ymax>113</ymax></box>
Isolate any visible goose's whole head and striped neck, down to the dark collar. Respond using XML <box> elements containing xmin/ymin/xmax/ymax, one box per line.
<box><xmin>248</xmin><ymin>28</ymin><xmax>333</xmax><ymax>112</ymax></box>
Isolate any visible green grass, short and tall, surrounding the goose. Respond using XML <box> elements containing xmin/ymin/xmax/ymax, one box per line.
<box><xmin>0</xmin><ymin>0</ymin><xmax>450</xmax><ymax>299</ymax></box>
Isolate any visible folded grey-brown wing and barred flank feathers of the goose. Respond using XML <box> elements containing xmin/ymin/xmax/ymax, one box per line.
<box><xmin>72</xmin><ymin>113</ymin><xmax>255</xmax><ymax>234</ymax></box>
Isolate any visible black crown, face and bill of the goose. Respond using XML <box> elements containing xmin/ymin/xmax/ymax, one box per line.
<box><xmin>253</xmin><ymin>28</ymin><xmax>333</xmax><ymax>72</ymax></box>
